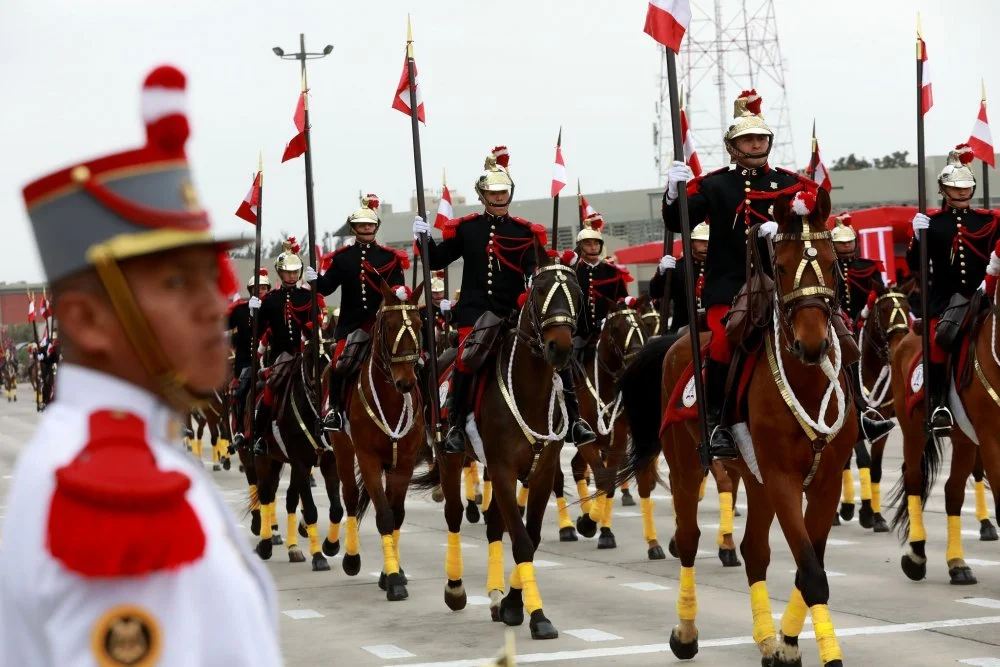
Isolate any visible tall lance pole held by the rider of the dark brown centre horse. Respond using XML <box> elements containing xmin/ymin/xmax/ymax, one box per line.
<box><xmin>406</xmin><ymin>15</ymin><xmax>441</xmax><ymax>444</ymax></box>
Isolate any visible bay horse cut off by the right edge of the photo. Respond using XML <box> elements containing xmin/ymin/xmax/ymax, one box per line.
<box><xmin>892</xmin><ymin>277</ymin><xmax>1000</xmax><ymax>585</ymax></box>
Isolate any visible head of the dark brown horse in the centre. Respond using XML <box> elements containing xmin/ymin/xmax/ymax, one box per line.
<box><xmin>522</xmin><ymin>241</ymin><xmax>583</xmax><ymax>370</ymax></box>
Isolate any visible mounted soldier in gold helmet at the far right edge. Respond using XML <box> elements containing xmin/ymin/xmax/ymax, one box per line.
<box><xmin>906</xmin><ymin>144</ymin><xmax>1000</xmax><ymax>437</ymax></box>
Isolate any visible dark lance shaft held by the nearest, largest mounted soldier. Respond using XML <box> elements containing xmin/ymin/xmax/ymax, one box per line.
<box><xmin>661</xmin><ymin>47</ymin><xmax>711</xmax><ymax>465</ymax></box>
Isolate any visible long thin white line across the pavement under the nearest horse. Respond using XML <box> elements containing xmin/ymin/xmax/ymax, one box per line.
<box><xmin>386</xmin><ymin>616</ymin><xmax>1000</xmax><ymax>667</ymax></box>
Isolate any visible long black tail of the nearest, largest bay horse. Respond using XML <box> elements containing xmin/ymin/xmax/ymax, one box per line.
<box><xmin>615</xmin><ymin>336</ymin><xmax>675</xmax><ymax>484</ymax></box>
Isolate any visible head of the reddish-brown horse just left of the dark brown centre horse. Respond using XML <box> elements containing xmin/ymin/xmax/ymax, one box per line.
<box><xmin>372</xmin><ymin>280</ymin><xmax>423</xmax><ymax>394</ymax></box>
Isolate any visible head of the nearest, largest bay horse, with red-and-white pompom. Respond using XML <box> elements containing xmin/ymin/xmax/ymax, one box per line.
<box><xmin>771</xmin><ymin>188</ymin><xmax>837</xmax><ymax>365</ymax></box>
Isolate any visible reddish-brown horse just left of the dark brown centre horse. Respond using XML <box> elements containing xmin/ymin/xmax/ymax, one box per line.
<box><xmin>332</xmin><ymin>281</ymin><xmax>426</xmax><ymax>602</ymax></box>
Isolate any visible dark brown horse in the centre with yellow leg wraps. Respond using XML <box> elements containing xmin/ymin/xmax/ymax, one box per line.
<box><xmin>414</xmin><ymin>242</ymin><xmax>583</xmax><ymax>639</ymax></box>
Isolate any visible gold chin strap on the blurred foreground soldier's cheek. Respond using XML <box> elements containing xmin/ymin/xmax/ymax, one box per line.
<box><xmin>92</xmin><ymin>252</ymin><xmax>208</xmax><ymax>414</ymax></box>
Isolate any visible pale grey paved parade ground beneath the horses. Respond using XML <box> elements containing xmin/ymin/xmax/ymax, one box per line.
<box><xmin>0</xmin><ymin>386</ymin><xmax>1000</xmax><ymax>667</ymax></box>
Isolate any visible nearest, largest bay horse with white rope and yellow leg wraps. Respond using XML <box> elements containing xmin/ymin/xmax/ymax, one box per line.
<box><xmin>624</xmin><ymin>189</ymin><xmax>858</xmax><ymax>667</ymax></box>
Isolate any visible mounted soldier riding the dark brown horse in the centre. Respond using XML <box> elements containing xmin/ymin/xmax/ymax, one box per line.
<box><xmin>413</xmin><ymin>146</ymin><xmax>594</xmax><ymax>454</ymax></box>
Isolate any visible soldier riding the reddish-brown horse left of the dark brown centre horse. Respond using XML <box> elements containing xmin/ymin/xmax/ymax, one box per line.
<box><xmin>306</xmin><ymin>194</ymin><xmax>410</xmax><ymax>431</ymax></box>
